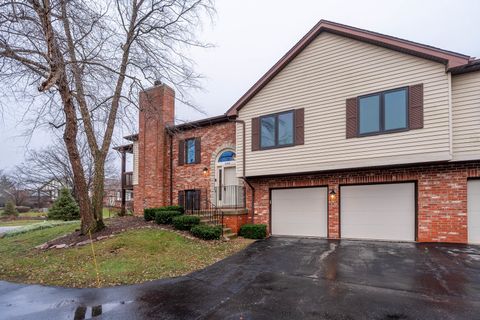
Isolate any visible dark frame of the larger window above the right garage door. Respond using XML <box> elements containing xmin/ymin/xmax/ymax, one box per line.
<box><xmin>357</xmin><ymin>86</ymin><xmax>410</xmax><ymax>137</ymax></box>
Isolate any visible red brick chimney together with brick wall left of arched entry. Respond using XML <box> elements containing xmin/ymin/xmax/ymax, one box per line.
<box><xmin>133</xmin><ymin>85</ymin><xmax>235</xmax><ymax>215</ymax></box>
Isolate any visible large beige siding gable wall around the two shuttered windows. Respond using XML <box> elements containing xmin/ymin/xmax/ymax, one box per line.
<box><xmin>237</xmin><ymin>33</ymin><xmax>451</xmax><ymax>176</ymax></box>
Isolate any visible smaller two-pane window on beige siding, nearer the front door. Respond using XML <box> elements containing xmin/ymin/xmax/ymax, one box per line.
<box><xmin>260</xmin><ymin>111</ymin><xmax>295</xmax><ymax>149</ymax></box>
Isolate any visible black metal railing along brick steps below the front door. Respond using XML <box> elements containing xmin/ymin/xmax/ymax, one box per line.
<box><xmin>178</xmin><ymin>189</ymin><xmax>224</xmax><ymax>237</ymax></box>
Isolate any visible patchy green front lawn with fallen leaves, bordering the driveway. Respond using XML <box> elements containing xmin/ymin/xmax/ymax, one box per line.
<box><xmin>0</xmin><ymin>225</ymin><xmax>251</xmax><ymax>287</ymax></box>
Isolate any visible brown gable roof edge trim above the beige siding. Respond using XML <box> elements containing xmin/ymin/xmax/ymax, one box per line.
<box><xmin>226</xmin><ymin>20</ymin><xmax>471</xmax><ymax>116</ymax></box>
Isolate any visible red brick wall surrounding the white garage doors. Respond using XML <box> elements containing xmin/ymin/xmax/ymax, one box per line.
<box><xmin>247</xmin><ymin>162</ymin><xmax>480</xmax><ymax>243</ymax></box>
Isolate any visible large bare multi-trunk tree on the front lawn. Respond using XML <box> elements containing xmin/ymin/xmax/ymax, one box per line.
<box><xmin>0</xmin><ymin>0</ymin><xmax>213</xmax><ymax>233</ymax></box>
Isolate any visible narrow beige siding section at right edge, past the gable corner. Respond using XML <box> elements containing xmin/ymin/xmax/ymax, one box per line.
<box><xmin>452</xmin><ymin>71</ymin><xmax>480</xmax><ymax>161</ymax></box>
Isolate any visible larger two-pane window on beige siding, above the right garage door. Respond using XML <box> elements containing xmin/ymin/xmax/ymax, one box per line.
<box><xmin>358</xmin><ymin>88</ymin><xmax>408</xmax><ymax>135</ymax></box>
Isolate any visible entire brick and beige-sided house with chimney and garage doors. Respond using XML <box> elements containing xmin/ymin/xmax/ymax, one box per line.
<box><xmin>116</xmin><ymin>21</ymin><xmax>480</xmax><ymax>243</ymax></box>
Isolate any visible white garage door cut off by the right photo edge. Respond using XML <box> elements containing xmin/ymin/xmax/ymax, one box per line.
<box><xmin>467</xmin><ymin>180</ymin><xmax>480</xmax><ymax>243</ymax></box>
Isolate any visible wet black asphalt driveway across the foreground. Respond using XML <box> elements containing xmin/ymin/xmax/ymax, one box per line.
<box><xmin>0</xmin><ymin>238</ymin><xmax>480</xmax><ymax>320</ymax></box>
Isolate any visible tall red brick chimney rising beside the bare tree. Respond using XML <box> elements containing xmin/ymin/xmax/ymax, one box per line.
<box><xmin>133</xmin><ymin>82</ymin><xmax>175</xmax><ymax>215</ymax></box>
